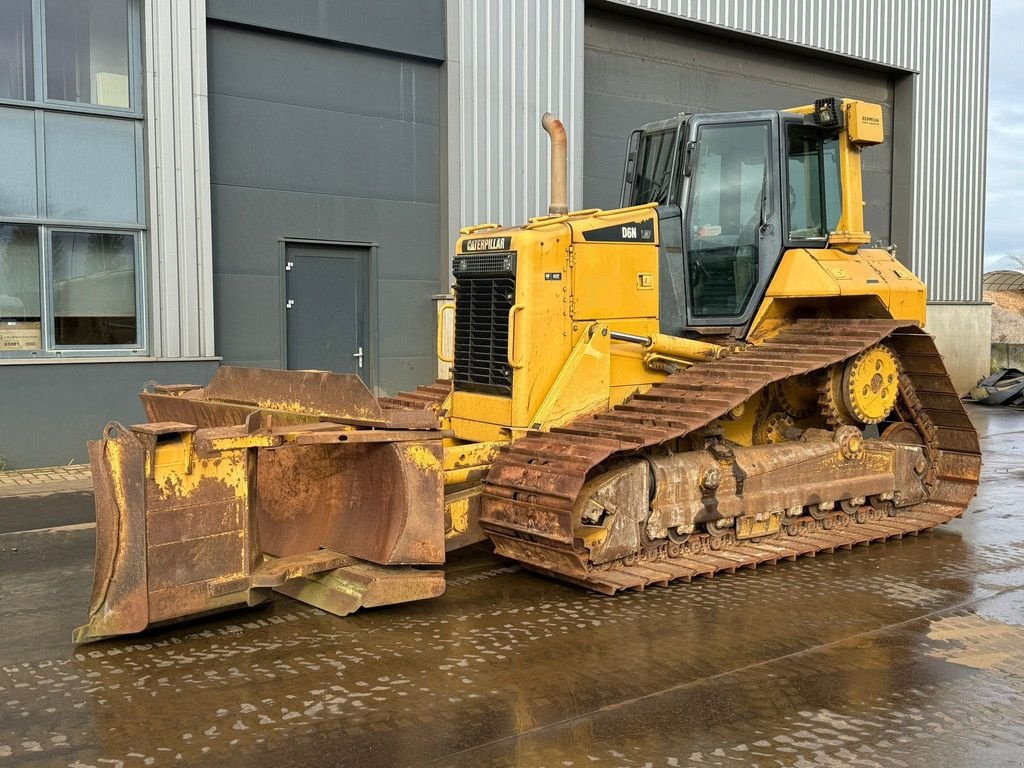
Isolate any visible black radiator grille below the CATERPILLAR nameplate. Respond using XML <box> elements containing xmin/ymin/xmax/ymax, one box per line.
<box><xmin>452</xmin><ymin>253</ymin><xmax>515</xmax><ymax>395</ymax></box>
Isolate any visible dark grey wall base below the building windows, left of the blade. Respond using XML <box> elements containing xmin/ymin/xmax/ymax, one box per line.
<box><xmin>0</xmin><ymin>360</ymin><xmax>217</xmax><ymax>469</ymax></box>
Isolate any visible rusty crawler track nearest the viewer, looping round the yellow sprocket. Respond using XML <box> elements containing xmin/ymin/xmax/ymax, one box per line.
<box><xmin>481</xmin><ymin>319</ymin><xmax>981</xmax><ymax>594</ymax></box>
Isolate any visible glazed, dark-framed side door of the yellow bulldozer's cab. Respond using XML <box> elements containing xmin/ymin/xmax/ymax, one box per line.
<box><xmin>681</xmin><ymin>112</ymin><xmax>782</xmax><ymax>328</ymax></box>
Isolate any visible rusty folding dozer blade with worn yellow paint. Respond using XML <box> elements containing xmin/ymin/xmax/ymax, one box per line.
<box><xmin>74</xmin><ymin>367</ymin><xmax>446</xmax><ymax>643</ymax></box>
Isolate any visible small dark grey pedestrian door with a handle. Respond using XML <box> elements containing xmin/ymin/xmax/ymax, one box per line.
<box><xmin>285</xmin><ymin>245</ymin><xmax>370</xmax><ymax>384</ymax></box>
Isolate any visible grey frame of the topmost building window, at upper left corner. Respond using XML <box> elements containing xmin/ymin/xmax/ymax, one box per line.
<box><xmin>0</xmin><ymin>0</ymin><xmax>143</xmax><ymax>119</ymax></box>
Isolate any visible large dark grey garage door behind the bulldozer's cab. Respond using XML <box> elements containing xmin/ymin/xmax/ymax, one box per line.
<box><xmin>583</xmin><ymin>8</ymin><xmax>893</xmax><ymax>242</ymax></box>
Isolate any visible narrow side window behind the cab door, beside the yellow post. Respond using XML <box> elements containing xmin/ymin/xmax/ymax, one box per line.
<box><xmin>786</xmin><ymin>125</ymin><xmax>843</xmax><ymax>243</ymax></box>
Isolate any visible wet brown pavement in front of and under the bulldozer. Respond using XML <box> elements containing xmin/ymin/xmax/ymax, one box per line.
<box><xmin>0</xmin><ymin>409</ymin><xmax>1024</xmax><ymax>768</ymax></box>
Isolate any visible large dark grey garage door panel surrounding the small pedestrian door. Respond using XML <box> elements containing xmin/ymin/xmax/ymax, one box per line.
<box><xmin>208</xmin><ymin>24</ymin><xmax>445</xmax><ymax>391</ymax></box>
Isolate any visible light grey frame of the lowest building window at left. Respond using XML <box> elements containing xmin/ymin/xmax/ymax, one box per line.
<box><xmin>0</xmin><ymin>218</ymin><xmax>150</xmax><ymax>361</ymax></box>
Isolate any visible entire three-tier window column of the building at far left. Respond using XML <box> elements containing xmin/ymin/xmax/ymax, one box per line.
<box><xmin>0</xmin><ymin>0</ymin><xmax>147</xmax><ymax>358</ymax></box>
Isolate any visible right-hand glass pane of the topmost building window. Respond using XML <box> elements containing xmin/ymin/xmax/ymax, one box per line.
<box><xmin>45</xmin><ymin>0</ymin><xmax>131</xmax><ymax>110</ymax></box>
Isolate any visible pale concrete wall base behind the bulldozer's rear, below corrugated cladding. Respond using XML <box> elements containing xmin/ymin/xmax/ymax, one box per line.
<box><xmin>925</xmin><ymin>303</ymin><xmax>992</xmax><ymax>394</ymax></box>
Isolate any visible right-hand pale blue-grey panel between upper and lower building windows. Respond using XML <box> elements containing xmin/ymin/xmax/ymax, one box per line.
<box><xmin>43</xmin><ymin>112</ymin><xmax>145</xmax><ymax>223</ymax></box>
